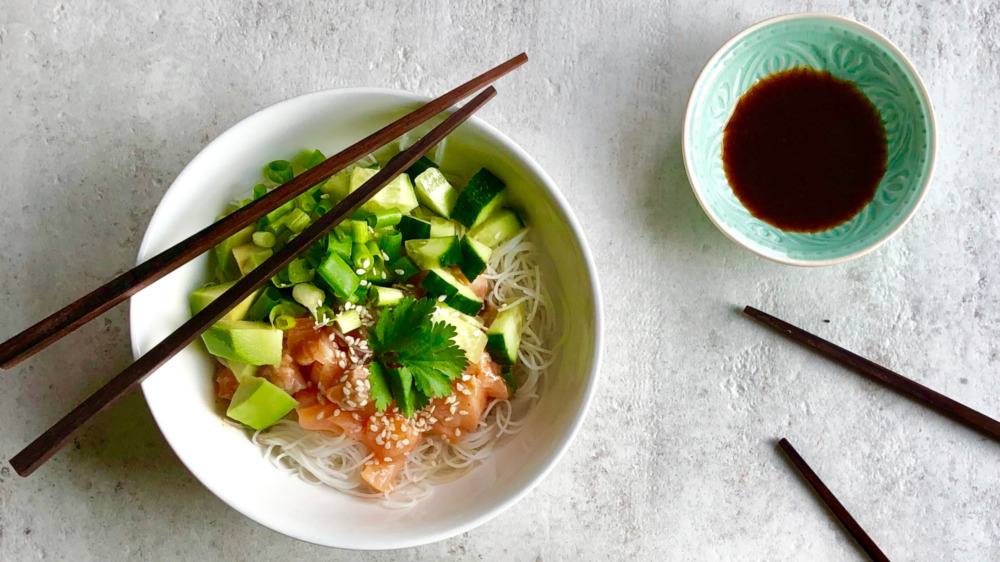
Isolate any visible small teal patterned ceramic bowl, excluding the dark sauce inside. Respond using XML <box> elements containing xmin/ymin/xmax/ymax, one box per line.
<box><xmin>683</xmin><ymin>14</ymin><xmax>935</xmax><ymax>266</ymax></box>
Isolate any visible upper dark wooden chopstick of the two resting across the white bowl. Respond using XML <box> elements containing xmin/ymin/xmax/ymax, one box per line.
<box><xmin>0</xmin><ymin>53</ymin><xmax>528</xmax><ymax>369</ymax></box>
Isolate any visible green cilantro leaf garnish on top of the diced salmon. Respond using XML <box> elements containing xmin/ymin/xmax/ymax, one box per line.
<box><xmin>368</xmin><ymin>298</ymin><xmax>469</xmax><ymax>417</ymax></box>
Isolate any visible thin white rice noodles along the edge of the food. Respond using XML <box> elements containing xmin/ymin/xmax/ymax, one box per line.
<box><xmin>246</xmin><ymin>230</ymin><xmax>555</xmax><ymax>508</ymax></box>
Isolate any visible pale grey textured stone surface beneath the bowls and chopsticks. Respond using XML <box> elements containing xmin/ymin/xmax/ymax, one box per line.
<box><xmin>0</xmin><ymin>0</ymin><xmax>1000</xmax><ymax>561</ymax></box>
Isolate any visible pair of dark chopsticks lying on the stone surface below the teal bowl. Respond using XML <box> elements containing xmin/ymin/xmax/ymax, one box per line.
<box><xmin>743</xmin><ymin>306</ymin><xmax>1000</xmax><ymax>561</ymax></box>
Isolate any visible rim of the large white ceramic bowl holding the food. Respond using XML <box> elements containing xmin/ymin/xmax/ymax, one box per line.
<box><xmin>129</xmin><ymin>87</ymin><xmax>604</xmax><ymax>551</ymax></box>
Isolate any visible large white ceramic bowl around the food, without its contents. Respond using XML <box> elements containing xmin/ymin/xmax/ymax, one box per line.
<box><xmin>130</xmin><ymin>89</ymin><xmax>602</xmax><ymax>550</ymax></box>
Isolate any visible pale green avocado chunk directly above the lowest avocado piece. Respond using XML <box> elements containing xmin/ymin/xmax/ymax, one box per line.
<box><xmin>201</xmin><ymin>320</ymin><xmax>282</xmax><ymax>365</ymax></box>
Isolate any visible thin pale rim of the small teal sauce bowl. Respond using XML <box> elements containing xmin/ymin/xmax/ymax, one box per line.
<box><xmin>681</xmin><ymin>12</ymin><xmax>937</xmax><ymax>267</ymax></box>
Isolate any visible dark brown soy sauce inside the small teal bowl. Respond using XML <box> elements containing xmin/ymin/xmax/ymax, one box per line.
<box><xmin>722</xmin><ymin>68</ymin><xmax>888</xmax><ymax>232</ymax></box>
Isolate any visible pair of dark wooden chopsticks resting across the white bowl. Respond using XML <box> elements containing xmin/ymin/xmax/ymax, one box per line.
<box><xmin>0</xmin><ymin>53</ymin><xmax>528</xmax><ymax>476</ymax></box>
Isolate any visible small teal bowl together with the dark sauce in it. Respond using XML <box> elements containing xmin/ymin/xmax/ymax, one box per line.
<box><xmin>684</xmin><ymin>14</ymin><xmax>935</xmax><ymax>265</ymax></box>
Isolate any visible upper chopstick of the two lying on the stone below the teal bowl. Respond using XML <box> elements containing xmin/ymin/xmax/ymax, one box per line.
<box><xmin>743</xmin><ymin>306</ymin><xmax>1000</xmax><ymax>441</ymax></box>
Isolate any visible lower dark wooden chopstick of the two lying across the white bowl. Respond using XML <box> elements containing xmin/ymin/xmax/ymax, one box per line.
<box><xmin>10</xmin><ymin>86</ymin><xmax>496</xmax><ymax>476</ymax></box>
